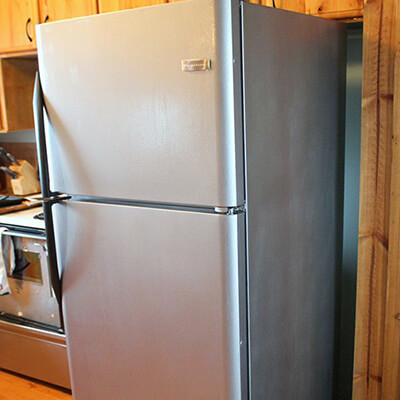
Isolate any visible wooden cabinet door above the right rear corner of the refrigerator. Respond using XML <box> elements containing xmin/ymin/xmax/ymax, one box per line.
<box><xmin>306</xmin><ymin>0</ymin><xmax>364</xmax><ymax>19</ymax></box>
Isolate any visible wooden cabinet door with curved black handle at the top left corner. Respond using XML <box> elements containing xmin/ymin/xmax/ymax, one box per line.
<box><xmin>0</xmin><ymin>0</ymin><xmax>39</xmax><ymax>53</ymax></box>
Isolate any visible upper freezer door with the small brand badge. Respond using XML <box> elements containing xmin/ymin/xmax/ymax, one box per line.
<box><xmin>37</xmin><ymin>0</ymin><xmax>243</xmax><ymax>206</ymax></box>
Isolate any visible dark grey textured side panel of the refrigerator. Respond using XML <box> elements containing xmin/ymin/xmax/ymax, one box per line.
<box><xmin>243</xmin><ymin>3</ymin><xmax>345</xmax><ymax>400</ymax></box>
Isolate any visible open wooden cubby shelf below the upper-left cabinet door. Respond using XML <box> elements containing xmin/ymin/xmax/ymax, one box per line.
<box><xmin>0</xmin><ymin>56</ymin><xmax>38</xmax><ymax>132</ymax></box>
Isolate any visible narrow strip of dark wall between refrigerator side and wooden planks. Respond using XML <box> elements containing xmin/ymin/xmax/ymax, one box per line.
<box><xmin>336</xmin><ymin>25</ymin><xmax>362</xmax><ymax>400</ymax></box>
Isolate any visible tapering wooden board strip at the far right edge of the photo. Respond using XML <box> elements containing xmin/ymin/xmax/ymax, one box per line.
<box><xmin>382</xmin><ymin>50</ymin><xmax>400</xmax><ymax>400</ymax></box>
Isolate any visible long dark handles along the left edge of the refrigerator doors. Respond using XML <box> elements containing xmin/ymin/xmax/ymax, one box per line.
<box><xmin>33</xmin><ymin>72</ymin><xmax>62</xmax><ymax>315</ymax></box>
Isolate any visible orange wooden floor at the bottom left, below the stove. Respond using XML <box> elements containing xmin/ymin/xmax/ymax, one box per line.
<box><xmin>0</xmin><ymin>369</ymin><xmax>72</xmax><ymax>400</ymax></box>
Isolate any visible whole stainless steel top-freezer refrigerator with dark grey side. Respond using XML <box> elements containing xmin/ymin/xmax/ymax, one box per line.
<box><xmin>35</xmin><ymin>0</ymin><xmax>345</xmax><ymax>400</ymax></box>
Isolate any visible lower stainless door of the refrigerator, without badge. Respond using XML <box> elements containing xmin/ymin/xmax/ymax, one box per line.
<box><xmin>54</xmin><ymin>202</ymin><xmax>246</xmax><ymax>400</ymax></box>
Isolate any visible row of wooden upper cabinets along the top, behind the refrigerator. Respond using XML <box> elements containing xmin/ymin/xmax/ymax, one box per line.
<box><xmin>0</xmin><ymin>0</ymin><xmax>364</xmax><ymax>53</ymax></box>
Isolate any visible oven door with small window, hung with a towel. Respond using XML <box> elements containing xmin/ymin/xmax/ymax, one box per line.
<box><xmin>0</xmin><ymin>230</ymin><xmax>61</xmax><ymax>329</ymax></box>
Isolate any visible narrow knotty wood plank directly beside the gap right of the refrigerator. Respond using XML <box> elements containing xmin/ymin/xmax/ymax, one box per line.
<box><xmin>353</xmin><ymin>1</ymin><xmax>382</xmax><ymax>394</ymax></box>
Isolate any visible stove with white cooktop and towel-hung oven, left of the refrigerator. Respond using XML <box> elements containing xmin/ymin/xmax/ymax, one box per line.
<box><xmin>0</xmin><ymin>206</ymin><xmax>71</xmax><ymax>388</ymax></box>
